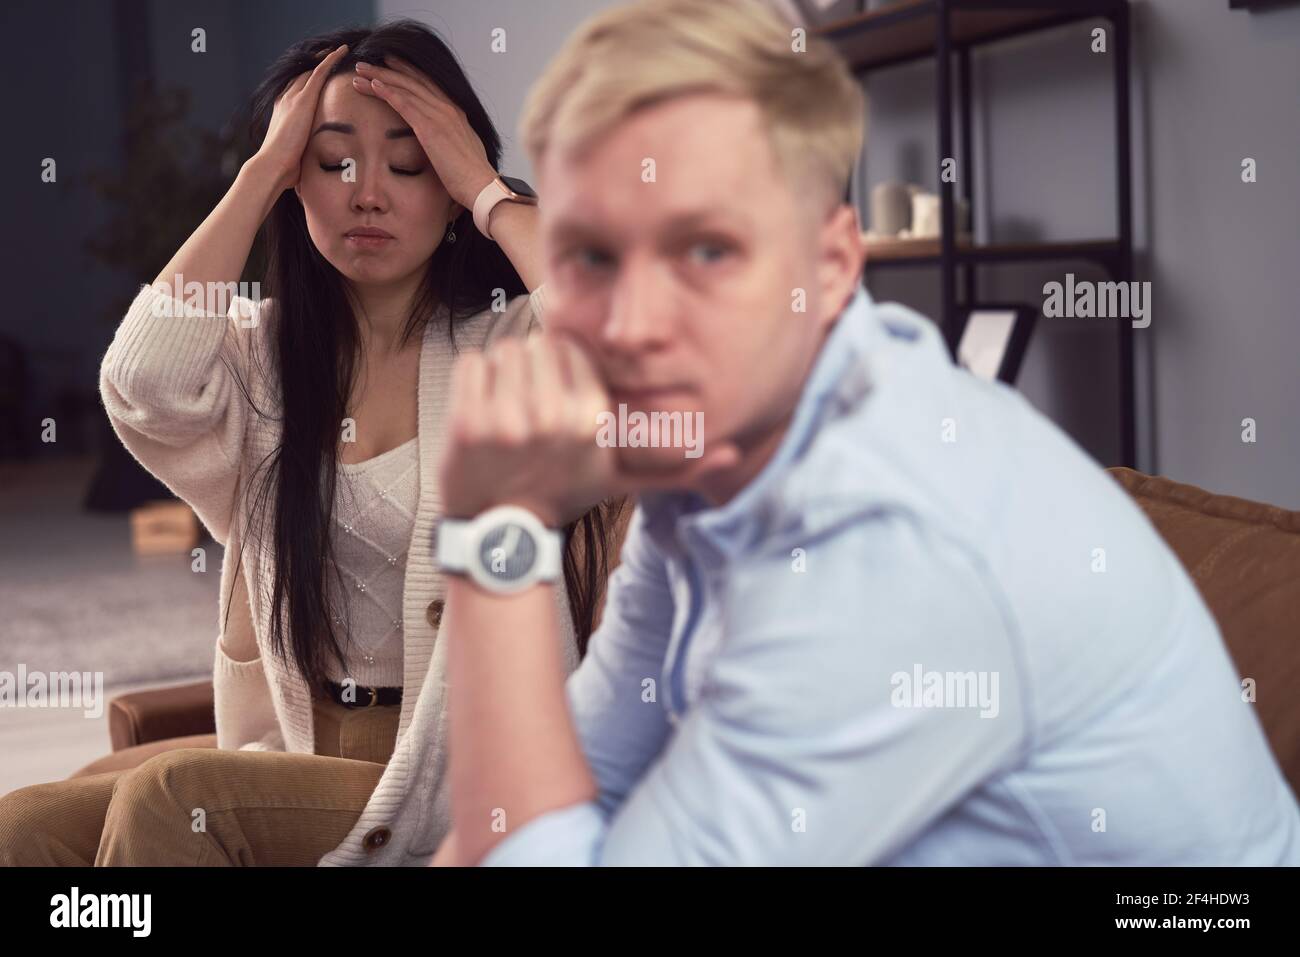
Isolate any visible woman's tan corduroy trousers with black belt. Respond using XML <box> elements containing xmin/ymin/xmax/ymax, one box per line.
<box><xmin>0</xmin><ymin>700</ymin><xmax>402</xmax><ymax>867</ymax></box>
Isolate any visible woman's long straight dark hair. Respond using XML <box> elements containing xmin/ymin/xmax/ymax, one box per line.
<box><xmin>226</xmin><ymin>20</ymin><xmax>618</xmax><ymax>689</ymax></box>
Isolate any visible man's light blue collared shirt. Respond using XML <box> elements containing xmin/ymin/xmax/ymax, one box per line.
<box><xmin>484</xmin><ymin>290</ymin><xmax>1300</xmax><ymax>865</ymax></box>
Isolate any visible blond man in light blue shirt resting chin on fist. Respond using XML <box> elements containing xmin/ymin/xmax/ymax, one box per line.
<box><xmin>436</xmin><ymin>0</ymin><xmax>1300</xmax><ymax>865</ymax></box>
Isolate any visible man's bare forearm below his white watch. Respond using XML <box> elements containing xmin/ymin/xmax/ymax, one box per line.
<box><xmin>443</xmin><ymin>577</ymin><xmax>595</xmax><ymax>865</ymax></box>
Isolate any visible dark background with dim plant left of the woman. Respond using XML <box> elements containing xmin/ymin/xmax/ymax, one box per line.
<box><xmin>0</xmin><ymin>0</ymin><xmax>374</xmax><ymax>508</ymax></box>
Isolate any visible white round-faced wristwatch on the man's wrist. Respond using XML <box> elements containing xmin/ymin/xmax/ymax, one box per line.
<box><xmin>437</xmin><ymin>505</ymin><xmax>564</xmax><ymax>594</ymax></box>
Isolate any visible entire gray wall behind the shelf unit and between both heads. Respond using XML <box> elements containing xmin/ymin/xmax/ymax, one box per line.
<box><xmin>392</xmin><ymin>0</ymin><xmax>1300</xmax><ymax>508</ymax></box>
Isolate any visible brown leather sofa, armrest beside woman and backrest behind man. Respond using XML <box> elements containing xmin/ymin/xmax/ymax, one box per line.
<box><xmin>74</xmin><ymin>468</ymin><xmax>1300</xmax><ymax>794</ymax></box>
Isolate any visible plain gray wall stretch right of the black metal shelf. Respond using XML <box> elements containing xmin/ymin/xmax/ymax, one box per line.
<box><xmin>1140</xmin><ymin>0</ymin><xmax>1300</xmax><ymax>508</ymax></box>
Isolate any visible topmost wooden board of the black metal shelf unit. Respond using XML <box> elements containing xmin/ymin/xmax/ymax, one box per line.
<box><xmin>813</xmin><ymin>0</ymin><xmax>1122</xmax><ymax>73</ymax></box>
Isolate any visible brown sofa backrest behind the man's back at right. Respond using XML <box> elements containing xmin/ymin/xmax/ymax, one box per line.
<box><xmin>1108</xmin><ymin>468</ymin><xmax>1300</xmax><ymax>794</ymax></box>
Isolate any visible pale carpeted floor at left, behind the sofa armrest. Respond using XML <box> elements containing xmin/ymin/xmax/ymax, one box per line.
<box><xmin>0</xmin><ymin>458</ymin><xmax>221</xmax><ymax>793</ymax></box>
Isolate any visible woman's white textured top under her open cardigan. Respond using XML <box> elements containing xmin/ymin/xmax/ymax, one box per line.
<box><xmin>329</xmin><ymin>436</ymin><xmax>420</xmax><ymax>688</ymax></box>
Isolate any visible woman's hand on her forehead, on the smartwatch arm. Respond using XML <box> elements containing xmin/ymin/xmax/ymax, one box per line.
<box><xmin>352</xmin><ymin>57</ymin><xmax>497</xmax><ymax>209</ymax></box>
